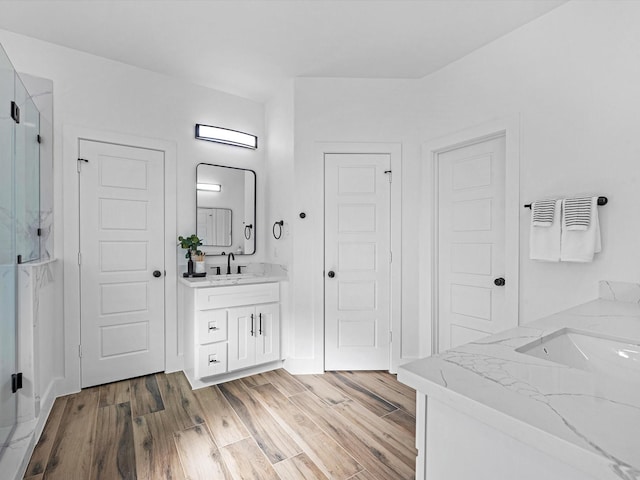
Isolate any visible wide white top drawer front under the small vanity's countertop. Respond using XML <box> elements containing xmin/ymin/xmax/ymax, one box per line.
<box><xmin>196</xmin><ymin>282</ymin><xmax>280</xmax><ymax>310</ymax></box>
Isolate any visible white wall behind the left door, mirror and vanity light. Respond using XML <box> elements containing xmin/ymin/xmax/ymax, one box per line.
<box><xmin>0</xmin><ymin>30</ymin><xmax>266</xmax><ymax>394</ymax></box>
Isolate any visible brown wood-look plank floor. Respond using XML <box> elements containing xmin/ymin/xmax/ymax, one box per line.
<box><xmin>25</xmin><ymin>370</ymin><xmax>416</xmax><ymax>480</ymax></box>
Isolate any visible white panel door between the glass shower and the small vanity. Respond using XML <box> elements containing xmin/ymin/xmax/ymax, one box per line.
<box><xmin>78</xmin><ymin>140</ymin><xmax>165</xmax><ymax>387</ymax></box>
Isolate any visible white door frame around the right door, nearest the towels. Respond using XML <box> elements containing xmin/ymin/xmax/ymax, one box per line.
<box><xmin>419</xmin><ymin>115</ymin><xmax>520</xmax><ymax>357</ymax></box>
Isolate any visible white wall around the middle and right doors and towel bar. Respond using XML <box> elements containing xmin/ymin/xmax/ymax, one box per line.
<box><xmin>293</xmin><ymin>1</ymin><xmax>640</xmax><ymax>366</ymax></box>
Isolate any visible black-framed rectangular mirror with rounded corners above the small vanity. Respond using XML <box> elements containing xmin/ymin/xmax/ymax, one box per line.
<box><xmin>196</xmin><ymin>163</ymin><xmax>256</xmax><ymax>255</ymax></box>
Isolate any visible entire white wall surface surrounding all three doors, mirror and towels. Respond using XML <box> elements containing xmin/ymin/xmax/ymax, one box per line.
<box><xmin>5</xmin><ymin>1</ymin><xmax>640</xmax><ymax>378</ymax></box>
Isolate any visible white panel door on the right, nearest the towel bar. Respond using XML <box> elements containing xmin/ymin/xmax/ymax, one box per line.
<box><xmin>436</xmin><ymin>136</ymin><xmax>510</xmax><ymax>352</ymax></box>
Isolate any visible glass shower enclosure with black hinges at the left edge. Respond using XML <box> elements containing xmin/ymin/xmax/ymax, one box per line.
<box><xmin>0</xmin><ymin>46</ymin><xmax>40</xmax><ymax>458</ymax></box>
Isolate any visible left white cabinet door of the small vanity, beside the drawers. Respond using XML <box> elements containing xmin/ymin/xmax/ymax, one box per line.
<box><xmin>227</xmin><ymin>307</ymin><xmax>256</xmax><ymax>370</ymax></box>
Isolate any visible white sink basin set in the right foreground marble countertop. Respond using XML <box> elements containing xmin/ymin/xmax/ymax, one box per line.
<box><xmin>516</xmin><ymin>328</ymin><xmax>640</xmax><ymax>381</ymax></box>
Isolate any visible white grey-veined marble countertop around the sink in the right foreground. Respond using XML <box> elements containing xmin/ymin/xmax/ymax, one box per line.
<box><xmin>398</xmin><ymin>282</ymin><xmax>640</xmax><ymax>480</ymax></box>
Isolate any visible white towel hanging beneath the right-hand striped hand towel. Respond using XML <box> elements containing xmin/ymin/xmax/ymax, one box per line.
<box><xmin>560</xmin><ymin>197</ymin><xmax>602</xmax><ymax>262</ymax></box>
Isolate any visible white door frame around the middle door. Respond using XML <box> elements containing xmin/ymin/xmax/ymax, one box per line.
<box><xmin>315</xmin><ymin>142</ymin><xmax>402</xmax><ymax>373</ymax></box>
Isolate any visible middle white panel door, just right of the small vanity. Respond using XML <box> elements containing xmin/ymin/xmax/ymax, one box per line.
<box><xmin>325</xmin><ymin>154</ymin><xmax>391</xmax><ymax>370</ymax></box>
